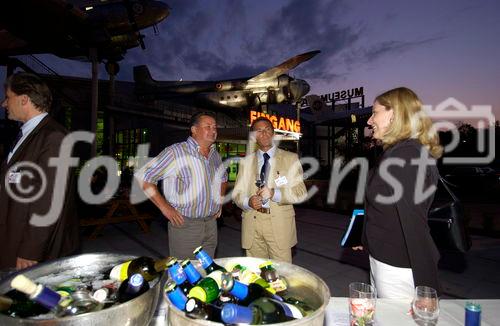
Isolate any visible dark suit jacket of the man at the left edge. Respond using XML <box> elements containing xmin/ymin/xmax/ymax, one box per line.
<box><xmin>0</xmin><ymin>116</ymin><xmax>79</xmax><ymax>269</ymax></box>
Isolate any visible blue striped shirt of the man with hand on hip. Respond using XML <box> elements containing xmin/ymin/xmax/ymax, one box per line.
<box><xmin>138</xmin><ymin>137</ymin><xmax>227</xmax><ymax>218</ymax></box>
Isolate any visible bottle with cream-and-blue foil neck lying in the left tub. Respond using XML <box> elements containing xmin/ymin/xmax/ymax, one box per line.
<box><xmin>10</xmin><ymin>274</ymin><xmax>102</xmax><ymax>317</ymax></box>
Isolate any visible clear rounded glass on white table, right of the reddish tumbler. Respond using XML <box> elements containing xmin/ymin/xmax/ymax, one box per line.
<box><xmin>412</xmin><ymin>286</ymin><xmax>439</xmax><ymax>326</ymax></box>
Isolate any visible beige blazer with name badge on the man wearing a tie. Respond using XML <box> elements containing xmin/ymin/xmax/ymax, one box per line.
<box><xmin>233</xmin><ymin>148</ymin><xmax>307</xmax><ymax>249</ymax></box>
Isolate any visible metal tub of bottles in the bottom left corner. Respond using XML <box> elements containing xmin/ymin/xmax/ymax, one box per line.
<box><xmin>0</xmin><ymin>253</ymin><xmax>162</xmax><ymax>326</ymax></box>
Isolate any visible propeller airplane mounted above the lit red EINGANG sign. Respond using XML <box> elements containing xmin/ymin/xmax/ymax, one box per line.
<box><xmin>134</xmin><ymin>50</ymin><xmax>321</xmax><ymax>109</ymax></box>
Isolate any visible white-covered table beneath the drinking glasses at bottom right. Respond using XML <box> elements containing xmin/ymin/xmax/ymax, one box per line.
<box><xmin>150</xmin><ymin>297</ymin><xmax>500</xmax><ymax>326</ymax></box>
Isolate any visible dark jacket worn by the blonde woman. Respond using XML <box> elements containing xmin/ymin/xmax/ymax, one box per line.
<box><xmin>363</xmin><ymin>139</ymin><xmax>440</xmax><ymax>291</ymax></box>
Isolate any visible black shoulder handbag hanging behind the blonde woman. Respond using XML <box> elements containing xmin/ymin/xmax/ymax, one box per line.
<box><xmin>428</xmin><ymin>176</ymin><xmax>471</xmax><ymax>253</ymax></box>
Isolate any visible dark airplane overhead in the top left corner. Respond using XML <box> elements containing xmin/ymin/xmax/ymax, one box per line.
<box><xmin>0</xmin><ymin>0</ymin><xmax>170</xmax><ymax>63</ymax></box>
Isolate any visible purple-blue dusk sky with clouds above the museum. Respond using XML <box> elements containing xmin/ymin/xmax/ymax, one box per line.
<box><xmin>2</xmin><ymin>0</ymin><xmax>500</xmax><ymax>119</ymax></box>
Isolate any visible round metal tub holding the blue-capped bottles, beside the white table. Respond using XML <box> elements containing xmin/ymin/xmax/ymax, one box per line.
<box><xmin>163</xmin><ymin>257</ymin><xmax>330</xmax><ymax>326</ymax></box>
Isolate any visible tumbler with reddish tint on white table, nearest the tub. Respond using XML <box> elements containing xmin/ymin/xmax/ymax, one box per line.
<box><xmin>349</xmin><ymin>282</ymin><xmax>377</xmax><ymax>326</ymax></box>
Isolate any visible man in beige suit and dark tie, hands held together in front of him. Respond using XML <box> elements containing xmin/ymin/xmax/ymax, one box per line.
<box><xmin>233</xmin><ymin>117</ymin><xmax>307</xmax><ymax>263</ymax></box>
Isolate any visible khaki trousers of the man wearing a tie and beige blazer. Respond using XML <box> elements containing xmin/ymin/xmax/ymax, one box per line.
<box><xmin>246</xmin><ymin>213</ymin><xmax>292</xmax><ymax>263</ymax></box>
